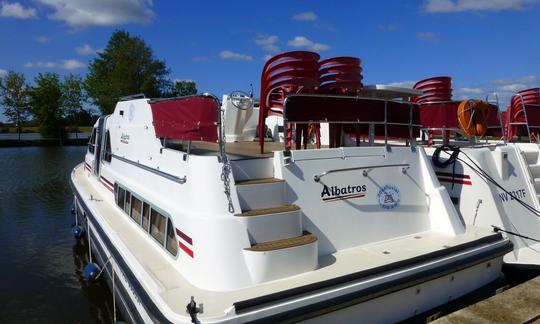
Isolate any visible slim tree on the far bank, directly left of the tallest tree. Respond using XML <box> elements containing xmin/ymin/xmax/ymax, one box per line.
<box><xmin>60</xmin><ymin>74</ymin><xmax>89</xmax><ymax>138</ymax></box>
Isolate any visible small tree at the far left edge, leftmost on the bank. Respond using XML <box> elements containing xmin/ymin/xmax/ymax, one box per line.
<box><xmin>0</xmin><ymin>71</ymin><xmax>30</xmax><ymax>141</ymax></box>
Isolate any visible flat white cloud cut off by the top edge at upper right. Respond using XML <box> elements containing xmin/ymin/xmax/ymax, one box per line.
<box><xmin>424</xmin><ymin>0</ymin><xmax>538</xmax><ymax>13</ymax></box>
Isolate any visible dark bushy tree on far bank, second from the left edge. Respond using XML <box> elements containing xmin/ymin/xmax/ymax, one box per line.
<box><xmin>30</xmin><ymin>73</ymin><xmax>64</xmax><ymax>138</ymax></box>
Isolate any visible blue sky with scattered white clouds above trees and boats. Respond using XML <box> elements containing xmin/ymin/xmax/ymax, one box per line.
<box><xmin>0</xmin><ymin>0</ymin><xmax>540</xmax><ymax>111</ymax></box>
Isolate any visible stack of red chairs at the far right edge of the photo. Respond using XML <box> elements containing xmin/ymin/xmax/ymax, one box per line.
<box><xmin>507</xmin><ymin>88</ymin><xmax>540</xmax><ymax>140</ymax></box>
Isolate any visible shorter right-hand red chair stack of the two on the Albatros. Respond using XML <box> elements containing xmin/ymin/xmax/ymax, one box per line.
<box><xmin>319</xmin><ymin>56</ymin><xmax>363</xmax><ymax>147</ymax></box>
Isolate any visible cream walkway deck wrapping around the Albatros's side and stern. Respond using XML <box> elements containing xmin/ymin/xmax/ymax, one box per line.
<box><xmin>73</xmin><ymin>164</ymin><xmax>498</xmax><ymax>319</ymax></box>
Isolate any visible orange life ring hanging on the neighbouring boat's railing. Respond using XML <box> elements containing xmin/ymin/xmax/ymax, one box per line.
<box><xmin>458</xmin><ymin>99</ymin><xmax>489</xmax><ymax>137</ymax></box>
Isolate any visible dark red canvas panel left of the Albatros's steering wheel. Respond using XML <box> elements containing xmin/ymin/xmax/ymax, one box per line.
<box><xmin>150</xmin><ymin>96</ymin><xmax>219</xmax><ymax>142</ymax></box>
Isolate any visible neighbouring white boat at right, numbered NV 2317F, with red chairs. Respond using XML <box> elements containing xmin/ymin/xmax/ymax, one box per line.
<box><xmin>390</xmin><ymin>77</ymin><xmax>540</xmax><ymax>265</ymax></box>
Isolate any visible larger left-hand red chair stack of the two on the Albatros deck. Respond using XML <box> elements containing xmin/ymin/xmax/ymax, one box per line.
<box><xmin>258</xmin><ymin>51</ymin><xmax>320</xmax><ymax>154</ymax></box>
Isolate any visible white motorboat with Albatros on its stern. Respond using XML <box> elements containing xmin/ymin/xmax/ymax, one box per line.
<box><xmin>71</xmin><ymin>89</ymin><xmax>512</xmax><ymax>323</ymax></box>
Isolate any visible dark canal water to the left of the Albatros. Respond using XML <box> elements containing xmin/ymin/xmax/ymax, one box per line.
<box><xmin>0</xmin><ymin>146</ymin><xmax>113</xmax><ymax>323</ymax></box>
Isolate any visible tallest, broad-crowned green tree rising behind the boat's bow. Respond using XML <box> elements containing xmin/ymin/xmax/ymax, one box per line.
<box><xmin>85</xmin><ymin>30</ymin><xmax>170</xmax><ymax>114</ymax></box>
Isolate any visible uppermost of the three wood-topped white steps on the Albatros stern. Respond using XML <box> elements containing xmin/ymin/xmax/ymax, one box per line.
<box><xmin>236</xmin><ymin>178</ymin><xmax>287</xmax><ymax>211</ymax></box>
